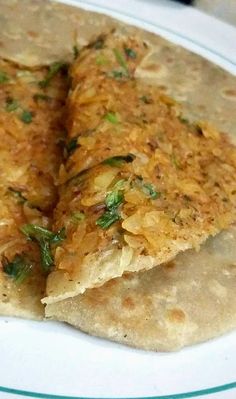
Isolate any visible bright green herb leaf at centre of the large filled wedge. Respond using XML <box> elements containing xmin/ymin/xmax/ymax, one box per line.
<box><xmin>96</xmin><ymin>190</ymin><xmax>124</xmax><ymax>229</ymax></box>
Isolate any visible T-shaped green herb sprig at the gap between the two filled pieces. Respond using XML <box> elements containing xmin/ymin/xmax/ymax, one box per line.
<box><xmin>20</xmin><ymin>224</ymin><xmax>66</xmax><ymax>272</ymax></box>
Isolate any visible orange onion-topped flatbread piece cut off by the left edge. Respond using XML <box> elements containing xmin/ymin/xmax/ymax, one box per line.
<box><xmin>0</xmin><ymin>60</ymin><xmax>66</xmax><ymax>319</ymax></box>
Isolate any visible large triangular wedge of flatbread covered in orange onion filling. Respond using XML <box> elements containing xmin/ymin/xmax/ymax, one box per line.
<box><xmin>44</xmin><ymin>33</ymin><xmax>236</xmax><ymax>303</ymax></box>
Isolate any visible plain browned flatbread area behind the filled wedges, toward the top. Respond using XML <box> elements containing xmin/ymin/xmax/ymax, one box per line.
<box><xmin>0</xmin><ymin>0</ymin><xmax>236</xmax><ymax>142</ymax></box>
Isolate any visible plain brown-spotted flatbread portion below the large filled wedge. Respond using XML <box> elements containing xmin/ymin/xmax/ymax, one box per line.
<box><xmin>46</xmin><ymin>227</ymin><xmax>236</xmax><ymax>351</ymax></box>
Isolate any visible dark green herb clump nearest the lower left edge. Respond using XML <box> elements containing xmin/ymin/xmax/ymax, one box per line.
<box><xmin>2</xmin><ymin>253</ymin><xmax>33</xmax><ymax>284</ymax></box>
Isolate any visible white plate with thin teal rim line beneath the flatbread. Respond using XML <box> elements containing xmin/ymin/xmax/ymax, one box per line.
<box><xmin>0</xmin><ymin>0</ymin><xmax>236</xmax><ymax>399</ymax></box>
